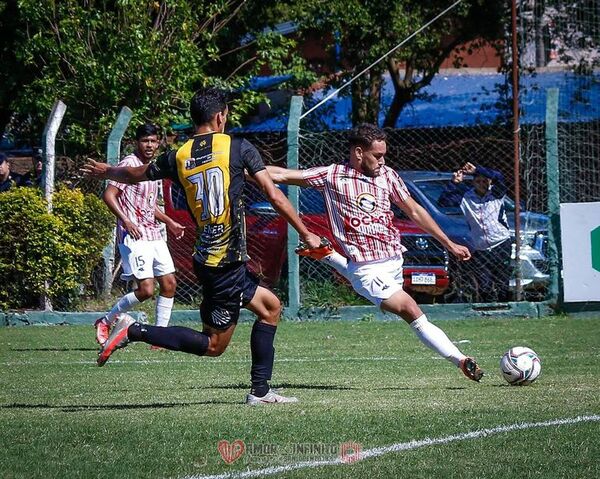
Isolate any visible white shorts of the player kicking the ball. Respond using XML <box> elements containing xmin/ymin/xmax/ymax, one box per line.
<box><xmin>346</xmin><ymin>257</ymin><xmax>404</xmax><ymax>306</ymax></box>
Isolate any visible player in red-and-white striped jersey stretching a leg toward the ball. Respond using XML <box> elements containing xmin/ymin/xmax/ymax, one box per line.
<box><xmin>267</xmin><ymin>124</ymin><xmax>483</xmax><ymax>381</ymax></box>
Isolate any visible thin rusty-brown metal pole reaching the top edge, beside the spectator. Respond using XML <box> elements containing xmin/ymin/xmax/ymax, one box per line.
<box><xmin>511</xmin><ymin>0</ymin><xmax>522</xmax><ymax>301</ymax></box>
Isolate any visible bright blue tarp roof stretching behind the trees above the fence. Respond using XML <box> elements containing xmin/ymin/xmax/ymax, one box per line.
<box><xmin>236</xmin><ymin>72</ymin><xmax>600</xmax><ymax>132</ymax></box>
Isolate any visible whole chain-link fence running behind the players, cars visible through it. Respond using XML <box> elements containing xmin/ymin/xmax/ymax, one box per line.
<box><xmin>27</xmin><ymin>99</ymin><xmax>600</xmax><ymax>309</ymax></box>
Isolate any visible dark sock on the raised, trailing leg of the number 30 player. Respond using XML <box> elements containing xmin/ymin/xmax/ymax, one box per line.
<box><xmin>127</xmin><ymin>323</ymin><xmax>208</xmax><ymax>356</ymax></box>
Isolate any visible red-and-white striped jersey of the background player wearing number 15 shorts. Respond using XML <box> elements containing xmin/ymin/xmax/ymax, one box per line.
<box><xmin>108</xmin><ymin>155</ymin><xmax>162</xmax><ymax>243</ymax></box>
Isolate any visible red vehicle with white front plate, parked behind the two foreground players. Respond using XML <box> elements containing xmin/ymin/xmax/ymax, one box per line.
<box><xmin>163</xmin><ymin>180</ymin><xmax>449</xmax><ymax>296</ymax></box>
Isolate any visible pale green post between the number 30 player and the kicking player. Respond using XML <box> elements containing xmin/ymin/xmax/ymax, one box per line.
<box><xmin>287</xmin><ymin>96</ymin><xmax>302</xmax><ymax>317</ymax></box>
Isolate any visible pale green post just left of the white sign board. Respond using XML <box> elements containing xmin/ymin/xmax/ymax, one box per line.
<box><xmin>546</xmin><ymin>88</ymin><xmax>560</xmax><ymax>307</ymax></box>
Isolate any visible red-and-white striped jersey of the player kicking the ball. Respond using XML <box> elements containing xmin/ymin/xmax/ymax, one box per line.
<box><xmin>302</xmin><ymin>164</ymin><xmax>410</xmax><ymax>262</ymax></box>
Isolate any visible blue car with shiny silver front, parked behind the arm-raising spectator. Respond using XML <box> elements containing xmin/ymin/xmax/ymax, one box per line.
<box><xmin>398</xmin><ymin>171</ymin><xmax>550</xmax><ymax>294</ymax></box>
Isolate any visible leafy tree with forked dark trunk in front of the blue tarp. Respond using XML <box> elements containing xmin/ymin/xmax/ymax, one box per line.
<box><xmin>275</xmin><ymin>0</ymin><xmax>507</xmax><ymax>127</ymax></box>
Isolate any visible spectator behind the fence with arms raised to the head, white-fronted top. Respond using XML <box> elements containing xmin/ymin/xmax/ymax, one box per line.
<box><xmin>438</xmin><ymin>163</ymin><xmax>512</xmax><ymax>302</ymax></box>
